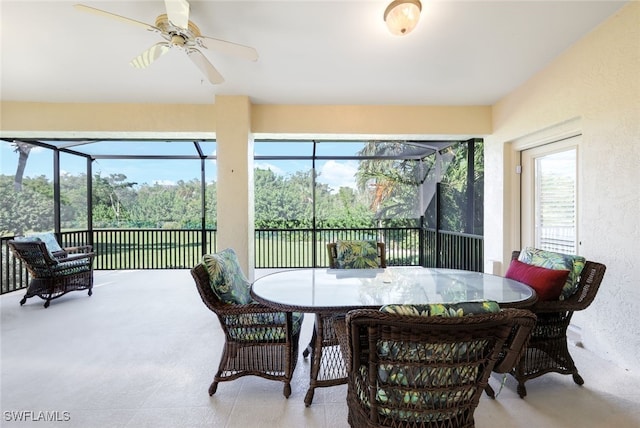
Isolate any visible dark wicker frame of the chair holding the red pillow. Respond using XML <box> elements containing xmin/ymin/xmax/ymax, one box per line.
<box><xmin>504</xmin><ymin>251</ymin><xmax>606</xmax><ymax>398</ymax></box>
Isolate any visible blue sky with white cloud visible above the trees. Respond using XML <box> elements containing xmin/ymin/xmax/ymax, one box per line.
<box><xmin>0</xmin><ymin>141</ymin><xmax>361</xmax><ymax>191</ymax></box>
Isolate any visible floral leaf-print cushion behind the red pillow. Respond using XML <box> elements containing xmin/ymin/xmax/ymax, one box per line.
<box><xmin>518</xmin><ymin>247</ymin><xmax>586</xmax><ymax>300</ymax></box>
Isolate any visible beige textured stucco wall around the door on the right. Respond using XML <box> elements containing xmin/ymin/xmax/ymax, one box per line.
<box><xmin>485</xmin><ymin>2</ymin><xmax>640</xmax><ymax>371</ymax></box>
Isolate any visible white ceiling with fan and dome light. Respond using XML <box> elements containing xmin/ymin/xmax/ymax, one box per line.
<box><xmin>0</xmin><ymin>0</ymin><xmax>625</xmax><ymax>105</ymax></box>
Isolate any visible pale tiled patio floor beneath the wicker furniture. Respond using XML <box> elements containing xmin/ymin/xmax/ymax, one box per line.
<box><xmin>0</xmin><ymin>270</ymin><xmax>640</xmax><ymax>428</ymax></box>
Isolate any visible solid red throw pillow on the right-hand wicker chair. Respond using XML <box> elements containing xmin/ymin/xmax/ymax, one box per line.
<box><xmin>505</xmin><ymin>260</ymin><xmax>569</xmax><ymax>300</ymax></box>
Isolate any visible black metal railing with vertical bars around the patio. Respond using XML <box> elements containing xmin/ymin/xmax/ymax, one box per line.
<box><xmin>0</xmin><ymin>228</ymin><xmax>483</xmax><ymax>294</ymax></box>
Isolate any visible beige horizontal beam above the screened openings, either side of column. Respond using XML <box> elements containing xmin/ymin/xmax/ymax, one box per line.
<box><xmin>0</xmin><ymin>100</ymin><xmax>491</xmax><ymax>138</ymax></box>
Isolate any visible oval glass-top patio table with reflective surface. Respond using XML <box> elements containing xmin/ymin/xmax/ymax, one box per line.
<box><xmin>251</xmin><ymin>267</ymin><xmax>536</xmax><ymax>313</ymax></box>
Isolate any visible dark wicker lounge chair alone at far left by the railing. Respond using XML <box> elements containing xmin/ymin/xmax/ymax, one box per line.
<box><xmin>8</xmin><ymin>235</ymin><xmax>95</xmax><ymax>308</ymax></box>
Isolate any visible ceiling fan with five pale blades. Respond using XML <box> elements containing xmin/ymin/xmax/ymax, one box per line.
<box><xmin>74</xmin><ymin>0</ymin><xmax>258</xmax><ymax>85</ymax></box>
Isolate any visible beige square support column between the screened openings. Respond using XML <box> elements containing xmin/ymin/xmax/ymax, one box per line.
<box><xmin>215</xmin><ymin>96</ymin><xmax>255</xmax><ymax>280</ymax></box>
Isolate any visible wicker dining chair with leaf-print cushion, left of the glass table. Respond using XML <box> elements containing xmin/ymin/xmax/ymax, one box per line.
<box><xmin>191</xmin><ymin>249</ymin><xmax>304</xmax><ymax>398</ymax></box>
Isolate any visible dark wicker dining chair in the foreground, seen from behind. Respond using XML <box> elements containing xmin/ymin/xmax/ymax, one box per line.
<box><xmin>339</xmin><ymin>302</ymin><xmax>535</xmax><ymax>428</ymax></box>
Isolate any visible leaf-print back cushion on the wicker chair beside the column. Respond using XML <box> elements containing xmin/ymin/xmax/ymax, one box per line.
<box><xmin>202</xmin><ymin>248</ymin><xmax>253</xmax><ymax>305</ymax></box>
